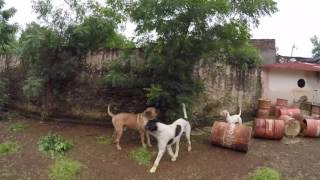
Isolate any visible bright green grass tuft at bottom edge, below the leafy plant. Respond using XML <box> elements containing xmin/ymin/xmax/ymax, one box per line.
<box><xmin>48</xmin><ymin>158</ymin><xmax>82</xmax><ymax>180</ymax></box>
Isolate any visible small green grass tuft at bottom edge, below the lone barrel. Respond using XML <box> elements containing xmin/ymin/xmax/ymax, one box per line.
<box><xmin>248</xmin><ymin>167</ymin><xmax>281</xmax><ymax>180</ymax></box>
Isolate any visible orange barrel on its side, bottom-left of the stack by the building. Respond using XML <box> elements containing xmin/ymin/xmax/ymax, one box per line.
<box><xmin>254</xmin><ymin>118</ymin><xmax>285</xmax><ymax>139</ymax></box>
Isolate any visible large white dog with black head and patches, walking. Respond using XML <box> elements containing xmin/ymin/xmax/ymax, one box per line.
<box><xmin>145</xmin><ymin>105</ymin><xmax>191</xmax><ymax>173</ymax></box>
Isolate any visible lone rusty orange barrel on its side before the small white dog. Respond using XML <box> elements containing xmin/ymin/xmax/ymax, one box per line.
<box><xmin>211</xmin><ymin>121</ymin><xmax>252</xmax><ymax>152</ymax></box>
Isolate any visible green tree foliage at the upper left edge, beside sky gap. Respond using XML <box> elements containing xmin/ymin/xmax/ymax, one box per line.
<box><xmin>0</xmin><ymin>0</ymin><xmax>18</xmax><ymax>54</ymax></box>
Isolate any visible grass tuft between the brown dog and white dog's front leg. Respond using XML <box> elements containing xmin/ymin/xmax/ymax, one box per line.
<box><xmin>130</xmin><ymin>147</ymin><xmax>152</xmax><ymax>166</ymax></box>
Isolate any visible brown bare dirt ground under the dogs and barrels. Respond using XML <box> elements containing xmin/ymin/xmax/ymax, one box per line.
<box><xmin>0</xmin><ymin>117</ymin><xmax>320</xmax><ymax>180</ymax></box>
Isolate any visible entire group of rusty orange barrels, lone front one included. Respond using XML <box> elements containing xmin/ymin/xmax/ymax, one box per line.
<box><xmin>211</xmin><ymin>98</ymin><xmax>320</xmax><ymax>152</ymax></box>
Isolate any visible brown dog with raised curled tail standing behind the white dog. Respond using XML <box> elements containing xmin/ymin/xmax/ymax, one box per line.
<box><xmin>108</xmin><ymin>105</ymin><xmax>157</xmax><ymax>150</ymax></box>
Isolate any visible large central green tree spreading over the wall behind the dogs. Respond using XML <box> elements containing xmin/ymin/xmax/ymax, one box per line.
<box><xmin>108</xmin><ymin>0</ymin><xmax>277</xmax><ymax>121</ymax></box>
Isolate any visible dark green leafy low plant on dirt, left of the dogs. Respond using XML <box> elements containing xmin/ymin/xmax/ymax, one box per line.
<box><xmin>38</xmin><ymin>133</ymin><xmax>73</xmax><ymax>158</ymax></box>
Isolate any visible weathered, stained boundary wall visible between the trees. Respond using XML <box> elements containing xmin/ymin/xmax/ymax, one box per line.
<box><xmin>0</xmin><ymin>49</ymin><xmax>261</xmax><ymax>125</ymax></box>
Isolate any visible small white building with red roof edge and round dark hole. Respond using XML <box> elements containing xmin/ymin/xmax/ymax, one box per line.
<box><xmin>261</xmin><ymin>59</ymin><xmax>320</xmax><ymax>104</ymax></box>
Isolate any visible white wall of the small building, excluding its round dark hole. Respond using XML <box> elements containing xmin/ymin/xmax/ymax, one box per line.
<box><xmin>261</xmin><ymin>69</ymin><xmax>320</xmax><ymax>104</ymax></box>
